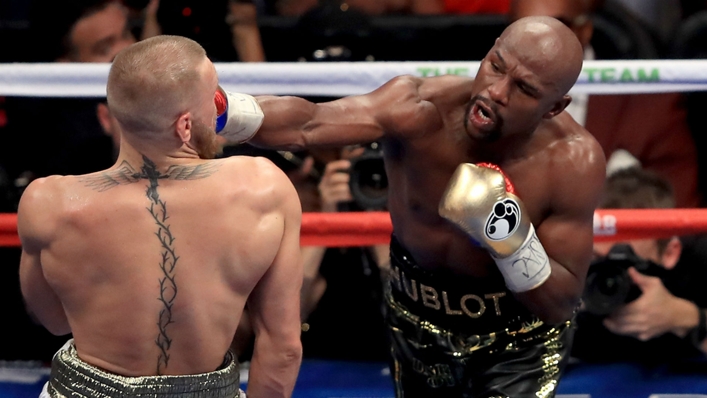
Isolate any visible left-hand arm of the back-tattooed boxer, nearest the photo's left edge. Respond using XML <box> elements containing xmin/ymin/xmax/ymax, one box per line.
<box><xmin>17</xmin><ymin>179</ymin><xmax>71</xmax><ymax>336</ymax></box>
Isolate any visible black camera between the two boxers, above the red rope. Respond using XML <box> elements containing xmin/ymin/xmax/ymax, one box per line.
<box><xmin>349</xmin><ymin>142</ymin><xmax>388</xmax><ymax>210</ymax></box>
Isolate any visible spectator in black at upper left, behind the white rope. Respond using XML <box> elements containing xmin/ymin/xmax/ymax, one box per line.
<box><xmin>3</xmin><ymin>0</ymin><xmax>135</xmax><ymax>183</ymax></box>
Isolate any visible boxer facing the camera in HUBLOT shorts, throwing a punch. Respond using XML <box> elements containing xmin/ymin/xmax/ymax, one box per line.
<box><xmin>217</xmin><ymin>17</ymin><xmax>605</xmax><ymax>398</ymax></box>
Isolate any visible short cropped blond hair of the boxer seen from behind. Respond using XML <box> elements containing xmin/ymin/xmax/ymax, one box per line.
<box><xmin>107</xmin><ymin>35</ymin><xmax>207</xmax><ymax>135</ymax></box>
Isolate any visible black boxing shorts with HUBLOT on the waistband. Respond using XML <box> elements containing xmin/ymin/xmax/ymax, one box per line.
<box><xmin>385</xmin><ymin>236</ymin><xmax>574</xmax><ymax>398</ymax></box>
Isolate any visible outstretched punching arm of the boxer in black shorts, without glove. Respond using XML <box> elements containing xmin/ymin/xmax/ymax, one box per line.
<box><xmin>250</xmin><ymin>76</ymin><xmax>439</xmax><ymax>150</ymax></box>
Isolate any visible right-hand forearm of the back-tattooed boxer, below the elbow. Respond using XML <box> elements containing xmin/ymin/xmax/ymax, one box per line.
<box><xmin>247</xmin><ymin>336</ymin><xmax>302</xmax><ymax>398</ymax></box>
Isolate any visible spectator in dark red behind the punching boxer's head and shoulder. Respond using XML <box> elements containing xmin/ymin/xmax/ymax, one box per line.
<box><xmin>509</xmin><ymin>0</ymin><xmax>701</xmax><ymax>207</ymax></box>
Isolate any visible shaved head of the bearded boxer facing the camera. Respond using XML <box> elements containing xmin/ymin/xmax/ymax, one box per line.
<box><xmin>465</xmin><ymin>16</ymin><xmax>584</xmax><ymax>141</ymax></box>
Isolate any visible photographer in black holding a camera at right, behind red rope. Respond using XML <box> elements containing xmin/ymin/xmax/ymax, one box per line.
<box><xmin>572</xmin><ymin>167</ymin><xmax>707</xmax><ymax>364</ymax></box>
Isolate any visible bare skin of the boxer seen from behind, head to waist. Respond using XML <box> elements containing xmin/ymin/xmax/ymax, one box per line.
<box><xmin>18</xmin><ymin>36</ymin><xmax>302</xmax><ymax>397</ymax></box>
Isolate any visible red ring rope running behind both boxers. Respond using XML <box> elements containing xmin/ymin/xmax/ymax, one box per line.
<box><xmin>0</xmin><ymin>209</ymin><xmax>707</xmax><ymax>246</ymax></box>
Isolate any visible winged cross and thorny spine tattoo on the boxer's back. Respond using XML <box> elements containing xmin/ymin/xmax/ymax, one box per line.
<box><xmin>81</xmin><ymin>156</ymin><xmax>216</xmax><ymax>375</ymax></box>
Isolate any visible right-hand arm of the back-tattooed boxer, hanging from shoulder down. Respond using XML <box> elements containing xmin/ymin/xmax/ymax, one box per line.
<box><xmin>248</xmin><ymin>174</ymin><xmax>302</xmax><ymax>398</ymax></box>
